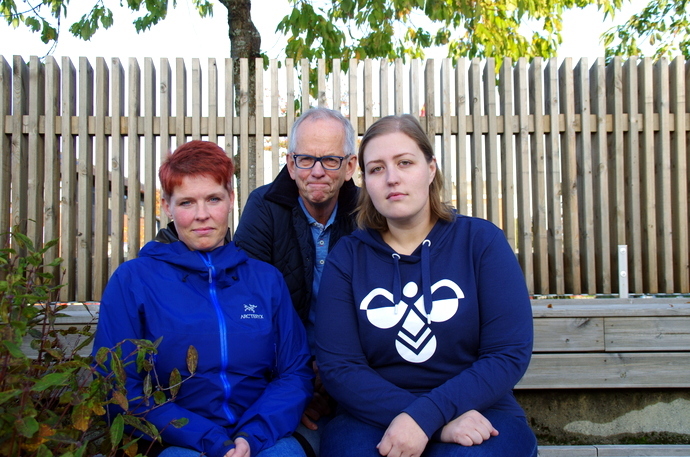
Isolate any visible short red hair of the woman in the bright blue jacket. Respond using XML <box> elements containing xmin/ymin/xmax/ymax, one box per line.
<box><xmin>158</xmin><ymin>140</ymin><xmax>235</xmax><ymax>199</ymax></box>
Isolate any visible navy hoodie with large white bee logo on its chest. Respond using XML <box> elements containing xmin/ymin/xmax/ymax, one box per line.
<box><xmin>316</xmin><ymin>216</ymin><xmax>532</xmax><ymax>438</ymax></box>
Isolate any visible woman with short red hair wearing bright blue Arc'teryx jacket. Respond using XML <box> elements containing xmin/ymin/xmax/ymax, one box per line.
<box><xmin>94</xmin><ymin>141</ymin><xmax>313</xmax><ymax>457</ymax></box>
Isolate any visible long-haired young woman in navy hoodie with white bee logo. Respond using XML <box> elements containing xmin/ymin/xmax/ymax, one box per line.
<box><xmin>316</xmin><ymin>115</ymin><xmax>537</xmax><ymax>457</ymax></box>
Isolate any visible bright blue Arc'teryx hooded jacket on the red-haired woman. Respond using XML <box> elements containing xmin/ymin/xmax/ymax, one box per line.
<box><xmin>94</xmin><ymin>235</ymin><xmax>313</xmax><ymax>457</ymax></box>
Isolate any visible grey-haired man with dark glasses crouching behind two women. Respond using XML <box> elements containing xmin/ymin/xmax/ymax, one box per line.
<box><xmin>234</xmin><ymin>108</ymin><xmax>358</xmax><ymax>452</ymax></box>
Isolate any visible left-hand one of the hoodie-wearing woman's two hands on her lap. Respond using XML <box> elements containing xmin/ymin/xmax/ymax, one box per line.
<box><xmin>376</xmin><ymin>413</ymin><xmax>429</xmax><ymax>457</ymax></box>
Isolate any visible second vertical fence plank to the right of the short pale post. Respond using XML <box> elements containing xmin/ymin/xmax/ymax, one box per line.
<box><xmin>637</xmin><ymin>58</ymin><xmax>670</xmax><ymax>294</ymax></box>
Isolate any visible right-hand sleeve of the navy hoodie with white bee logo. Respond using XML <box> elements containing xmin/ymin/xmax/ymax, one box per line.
<box><xmin>404</xmin><ymin>229</ymin><xmax>533</xmax><ymax>437</ymax></box>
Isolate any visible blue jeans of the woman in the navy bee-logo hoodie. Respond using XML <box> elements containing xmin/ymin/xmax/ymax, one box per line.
<box><xmin>321</xmin><ymin>409</ymin><xmax>537</xmax><ymax>457</ymax></box>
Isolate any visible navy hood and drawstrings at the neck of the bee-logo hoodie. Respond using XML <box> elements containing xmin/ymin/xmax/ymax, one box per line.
<box><xmin>352</xmin><ymin>220</ymin><xmax>452</xmax><ymax>323</ymax></box>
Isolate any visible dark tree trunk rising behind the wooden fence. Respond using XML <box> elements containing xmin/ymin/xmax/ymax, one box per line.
<box><xmin>221</xmin><ymin>0</ymin><xmax>261</xmax><ymax>210</ymax></box>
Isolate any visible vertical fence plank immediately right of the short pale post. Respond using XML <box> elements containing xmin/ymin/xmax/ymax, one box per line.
<box><xmin>620</xmin><ymin>57</ymin><xmax>644</xmax><ymax>292</ymax></box>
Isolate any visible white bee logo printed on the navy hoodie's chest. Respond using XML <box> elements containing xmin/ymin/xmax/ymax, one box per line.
<box><xmin>359</xmin><ymin>279</ymin><xmax>465</xmax><ymax>363</ymax></box>
